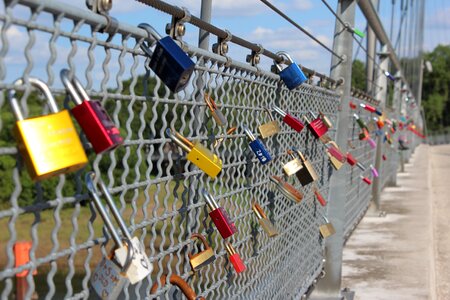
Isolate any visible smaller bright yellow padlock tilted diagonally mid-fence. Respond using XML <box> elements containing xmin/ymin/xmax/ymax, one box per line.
<box><xmin>166</xmin><ymin>128</ymin><xmax>222</xmax><ymax>178</ymax></box>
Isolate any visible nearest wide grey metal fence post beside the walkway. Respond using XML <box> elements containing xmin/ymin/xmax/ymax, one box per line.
<box><xmin>312</xmin><ymin>0</ymin><xmax>356</xmax><ymax>299</ymax></box>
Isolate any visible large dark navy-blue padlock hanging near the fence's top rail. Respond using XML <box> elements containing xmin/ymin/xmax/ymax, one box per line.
<box><xmin>138</xmin><ymin>23</ymin><xmax>195</xmax><ymax>93</ymax></box>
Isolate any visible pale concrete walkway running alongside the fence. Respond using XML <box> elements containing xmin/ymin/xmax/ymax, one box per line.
<box><xmin>342</xmin><ymin>145</ymin><xmax>450</xmax><ymax>300</ymax></box>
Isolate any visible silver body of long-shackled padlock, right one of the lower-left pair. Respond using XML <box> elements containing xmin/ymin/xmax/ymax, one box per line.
<box><xmin>114</xmin><ymin>237</ymin><xmax>152</xmax><ymax>284</ymax></box>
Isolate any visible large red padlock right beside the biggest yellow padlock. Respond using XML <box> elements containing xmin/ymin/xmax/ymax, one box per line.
<box><xmin>60</xmin><ymin>69</ymin><xmax>123</xmax><ymax>154</ymax></box>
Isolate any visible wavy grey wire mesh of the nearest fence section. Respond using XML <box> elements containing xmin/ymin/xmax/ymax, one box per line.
<box><xmin>0</xmin><ymin>1</ymin><xmax>344</xmax><ymax>299</ymax></box>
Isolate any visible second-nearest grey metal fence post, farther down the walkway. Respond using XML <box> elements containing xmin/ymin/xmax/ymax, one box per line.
<box><xmin>372</xmin><ymin>45</ymin><xmax>389</xmax><ymax>212</ymax></box>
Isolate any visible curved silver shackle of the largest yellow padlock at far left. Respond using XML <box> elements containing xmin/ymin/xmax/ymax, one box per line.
<box><xmin>7</xmin><ymin>77</ymin><xmax>59</xmax><ymax>121</ymax></box>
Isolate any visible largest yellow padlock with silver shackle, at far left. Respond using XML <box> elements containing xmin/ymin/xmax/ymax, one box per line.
<box><xmin>8</xmin><ymin>77</ymin><xmax>88</xmax><ymax>181</ymax></box>
